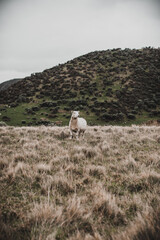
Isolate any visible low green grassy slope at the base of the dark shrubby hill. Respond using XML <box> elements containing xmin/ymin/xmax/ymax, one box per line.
<box><xmin>0</xmin><ymin>103</ymin><xmax>159</xmax><ymax>126</ymax></box>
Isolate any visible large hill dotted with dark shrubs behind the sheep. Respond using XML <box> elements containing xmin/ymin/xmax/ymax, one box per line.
<box><xmin>0</xmin><ymin>48</ymin><xmax>160</xmax><ymax>125</ymax></box>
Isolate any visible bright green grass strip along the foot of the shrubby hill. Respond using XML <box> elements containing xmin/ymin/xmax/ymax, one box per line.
<box><xmin>0</xmin><ymin>103</ymin><xmax>159</xmax><ymax>127</ymax></box>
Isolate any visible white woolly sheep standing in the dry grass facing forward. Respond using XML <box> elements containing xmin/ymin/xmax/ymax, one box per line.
<box><xmin>69</xmin><ymin>111</ymin><xmax>87</xmax><ymax>139</ymax></box>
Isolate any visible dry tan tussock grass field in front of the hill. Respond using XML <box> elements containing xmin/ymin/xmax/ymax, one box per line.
<box><xmin>0</xmin><ymin>126</ymin><xmax>160</xmax><ymax>240</ymax></box>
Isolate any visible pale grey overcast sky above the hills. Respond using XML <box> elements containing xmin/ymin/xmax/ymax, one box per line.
<box><xmin>0</xmin><ymin>0</ymin><xmax>160</xmax><ymax>83</ymax></box>
